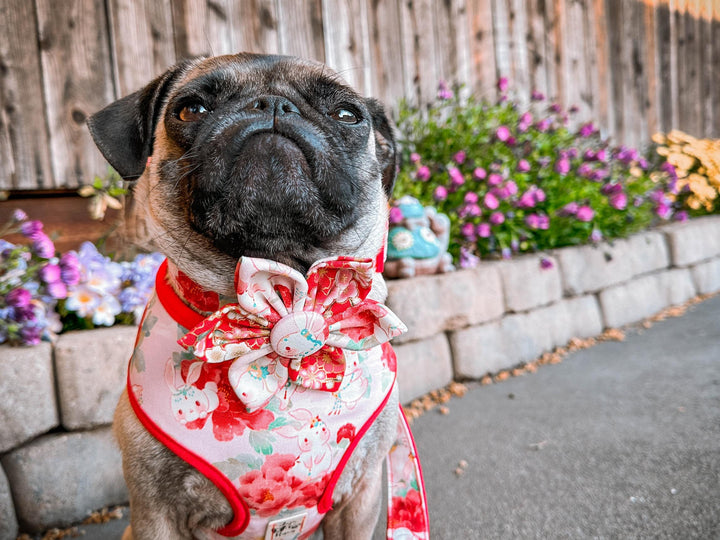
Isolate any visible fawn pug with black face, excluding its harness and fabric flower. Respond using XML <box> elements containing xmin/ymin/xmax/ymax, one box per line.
<box><xmin>88</xmin><ymin>54</ymin><xmax>399</xmax><ymax>540</ymax></box>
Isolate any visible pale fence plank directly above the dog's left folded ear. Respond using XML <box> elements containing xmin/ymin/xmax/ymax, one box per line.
<box><xmin>107</xmin><ymin>0</ymin><xmax>175</xmax><ymax>96</ymax></box>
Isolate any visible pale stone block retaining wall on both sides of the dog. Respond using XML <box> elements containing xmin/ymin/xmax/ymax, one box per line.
<box><xmin>0</xmin><ymin>216</ymin><xmax>720</xmax><ymax>540</ymax></box>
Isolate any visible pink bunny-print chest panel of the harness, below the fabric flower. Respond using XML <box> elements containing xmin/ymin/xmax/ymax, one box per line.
<box><xmin>128</xmin><ymin>297</ymin><xmax>395</xmax><ymax>538</ymax></box>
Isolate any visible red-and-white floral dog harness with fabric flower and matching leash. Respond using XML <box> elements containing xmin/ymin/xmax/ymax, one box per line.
<box><xmin>128</xmin><ymin>257</ymin><xmax>428</xmax><ymax>540</ymax></box>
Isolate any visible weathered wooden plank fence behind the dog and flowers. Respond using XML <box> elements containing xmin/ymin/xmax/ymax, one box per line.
<box><xmin>0</xmin><ymin>0</ymin><xmax>720</xmax><ymax>190</ymax></box>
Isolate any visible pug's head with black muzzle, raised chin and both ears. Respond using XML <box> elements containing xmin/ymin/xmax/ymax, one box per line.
<box><xmin>88</xmin><ymin>54</ymin><xmax>397</xmax><ymax>292</ymax></box>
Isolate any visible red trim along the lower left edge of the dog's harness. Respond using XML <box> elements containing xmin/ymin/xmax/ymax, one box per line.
<box><xmin>127</xmin><ymin>369</ymin><xmax>250</xmax><ymax>536</ymax></box>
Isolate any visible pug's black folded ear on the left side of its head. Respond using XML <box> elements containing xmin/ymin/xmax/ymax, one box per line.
<box><xmin>87</xmin><ymin>60</ymin><xmax>192</xmax><ymax>179</ymax></box>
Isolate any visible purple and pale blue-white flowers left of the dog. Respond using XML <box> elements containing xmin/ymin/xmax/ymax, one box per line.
<box><xmin>0</xmin><ymin>210</ymin><xmax>163</xmax><ymax>345</ymax></box>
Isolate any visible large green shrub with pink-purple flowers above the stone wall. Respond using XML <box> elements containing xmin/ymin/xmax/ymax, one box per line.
<box><xmin>397</xmin><ymin>79</ymin><xmax>683</xmax><ymax>266</ymax></box>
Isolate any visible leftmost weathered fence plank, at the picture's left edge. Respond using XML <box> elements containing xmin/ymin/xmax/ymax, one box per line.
<box><xmin>0</xmin><ymin>0</ymin><xmax>54</xmax><ymax>190</ymax></box>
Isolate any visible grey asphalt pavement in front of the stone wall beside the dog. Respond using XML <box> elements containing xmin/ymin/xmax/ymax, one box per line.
<box><xmin>60</xmin><ymin>297</ymin><xmax>720</xmax><ymax>540</ymax></box>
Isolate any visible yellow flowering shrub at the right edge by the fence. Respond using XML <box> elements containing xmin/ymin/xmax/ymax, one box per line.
<box><xmin>652</xmin><ymin>130</ymin><xmax>720</xmax><ymax>214</ymax></box>
